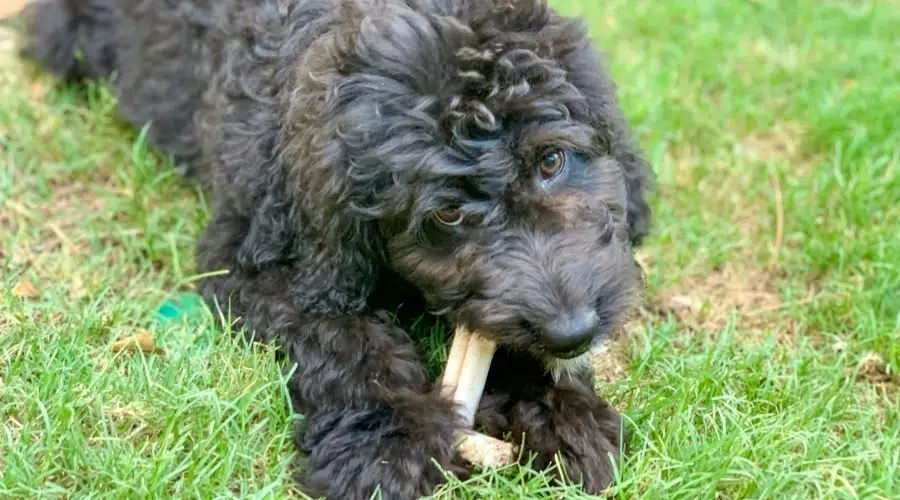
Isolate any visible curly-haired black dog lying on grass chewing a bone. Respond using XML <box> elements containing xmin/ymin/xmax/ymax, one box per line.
<box><xmin>19</xmin><ymin>0</ymin><xmax>650</xmax><ymax>499</ymax></box>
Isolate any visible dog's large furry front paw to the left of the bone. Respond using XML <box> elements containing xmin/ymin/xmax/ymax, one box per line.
<box><xmin>296</xmin><ymin>395</ymin><xmax>468</xmax><ymax>500</ymax></box>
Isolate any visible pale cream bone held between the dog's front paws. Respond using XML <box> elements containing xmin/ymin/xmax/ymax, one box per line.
<box><xmin>441</xmin><ymin>327</ymin><xmax>516</xmax><ymax>467</ymax></box>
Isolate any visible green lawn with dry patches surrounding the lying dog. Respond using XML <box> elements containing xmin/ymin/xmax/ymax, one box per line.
<box><xmin>0</xmin><ymin>0</ymin><xmax>900</xmax><ymax>499</ymax></box>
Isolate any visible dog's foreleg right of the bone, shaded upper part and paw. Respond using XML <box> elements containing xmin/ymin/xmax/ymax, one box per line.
<box><xmin>476</xmin><ymin>351</ymin><xmax>625</xmax><ymax>494</ymax></box>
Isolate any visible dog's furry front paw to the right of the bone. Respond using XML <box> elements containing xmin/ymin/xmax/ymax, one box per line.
<box><xmin>510</xmin><ymin>383</ymin><xmax>623</xmax><ymax>494</ymax></box>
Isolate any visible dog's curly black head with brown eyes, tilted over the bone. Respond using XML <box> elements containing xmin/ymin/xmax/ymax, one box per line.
<box><xmin>292</xmin><ymin>0</ymin><xmax>649</xmax><ymax>372</ymax></box>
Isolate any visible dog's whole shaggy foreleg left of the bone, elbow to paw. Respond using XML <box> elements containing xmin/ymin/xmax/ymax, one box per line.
<box><xmin>193</xmin><ymin>210</ymin><xmax>467</xmax><ymax>500</ymax></box>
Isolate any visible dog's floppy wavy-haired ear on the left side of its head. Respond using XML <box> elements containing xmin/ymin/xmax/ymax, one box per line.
<box><xmin>279</xmin><ymin>0</ymin><xmax>472</xmax><ymax>262</ymax></box>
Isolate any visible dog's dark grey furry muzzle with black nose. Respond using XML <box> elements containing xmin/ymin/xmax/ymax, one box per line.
<box><xmin>459</xmin><ymin>221</ymin><xmax>640</xmax><ymax>359</ymax></box>
